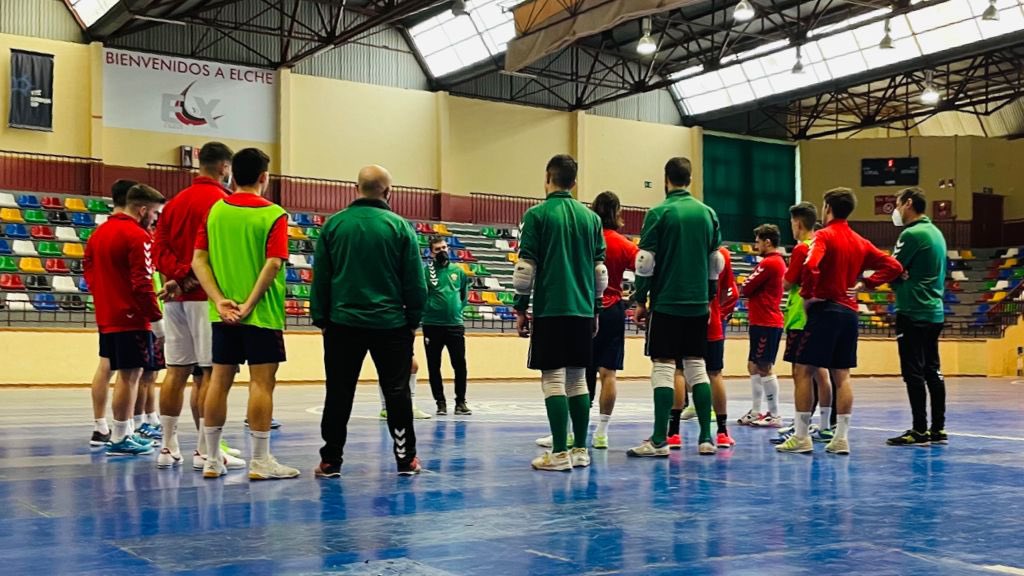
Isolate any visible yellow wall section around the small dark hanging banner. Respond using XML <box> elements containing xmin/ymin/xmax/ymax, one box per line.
<box><xmin>0</xmin><ymin>34</ymin><xmax>93</xmax><ymax>157</ymax></box>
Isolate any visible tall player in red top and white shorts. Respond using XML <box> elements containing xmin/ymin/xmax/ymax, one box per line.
<box><xmin>155</xmin><ymin>142</ymin><xmax>246</xmax><ymax>470</ymax></box>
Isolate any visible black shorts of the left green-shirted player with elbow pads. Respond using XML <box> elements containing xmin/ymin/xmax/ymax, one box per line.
<box><xmin>526</xmin><ymin>316</ymin><xmax>593</xmax><ymax>370</ymax></box>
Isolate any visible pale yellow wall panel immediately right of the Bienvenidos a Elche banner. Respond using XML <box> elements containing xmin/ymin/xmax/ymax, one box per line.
<box><xmin>283</xmin><ymin>74</ymin><xmax>438</xmax><ymax>188</ymax></box>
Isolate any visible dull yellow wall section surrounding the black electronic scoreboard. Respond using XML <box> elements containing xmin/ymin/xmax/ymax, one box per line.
<box><xmin>800</xmin><ymin>136</ymin><xmax>980</xmax><ymax>220</ymax></box>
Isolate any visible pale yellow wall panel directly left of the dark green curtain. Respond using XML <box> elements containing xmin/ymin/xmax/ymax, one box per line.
<box><xmin>580</xmin><ymin>115</ymin><xmax>699</xmax><ymax>206</ymax></box>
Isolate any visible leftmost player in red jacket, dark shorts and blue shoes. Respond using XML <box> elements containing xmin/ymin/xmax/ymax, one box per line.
<box><xmin>82</xmin><ymin>184</ymin><xmax>164</xmax><ymax>456</ymax></box>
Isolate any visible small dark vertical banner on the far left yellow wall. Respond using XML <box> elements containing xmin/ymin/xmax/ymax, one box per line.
<box><xmin>8</xmin><ymin>50</ymin><xmax>53</xmax><ymax>132</ymax></box>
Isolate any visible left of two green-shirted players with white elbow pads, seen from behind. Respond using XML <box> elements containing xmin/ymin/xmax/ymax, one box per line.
<box><xmin>512</xmin><ymin>155</ymin><xmax>613</xmax><ymax>471</ymax></box>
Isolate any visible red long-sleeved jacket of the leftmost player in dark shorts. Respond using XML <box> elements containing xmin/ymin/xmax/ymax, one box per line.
<box><xmin>82</xmin><ymin>213</ymin><xmax>163</xmax><ymax>334</ymax></box>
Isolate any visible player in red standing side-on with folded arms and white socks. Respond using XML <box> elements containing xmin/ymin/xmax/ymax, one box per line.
<box><xmin>738</xmin><ymin>224</ymin><xmax>785</xmax><ymax>428</ymax></box>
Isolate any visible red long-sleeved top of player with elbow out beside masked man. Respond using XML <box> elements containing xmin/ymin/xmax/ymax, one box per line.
<box><xmin>800</xmin><ymin>219</ymin><xmax>903</xmax><ymax>312</ymax></box>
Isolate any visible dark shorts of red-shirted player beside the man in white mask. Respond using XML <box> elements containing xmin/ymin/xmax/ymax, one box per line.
<box><xmin>797</xmin><ymin>302</ymin><xmax>859</xmax><ymax>369</ymax></box>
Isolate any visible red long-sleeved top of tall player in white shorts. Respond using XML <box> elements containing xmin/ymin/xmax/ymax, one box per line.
<box><xmin>155</xmin><ymin>176</ymin><xmax>227</xmax><ymax>302</ymax></box>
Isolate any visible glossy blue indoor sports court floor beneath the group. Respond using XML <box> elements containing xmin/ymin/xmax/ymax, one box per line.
<box><xmin>0</xmin><ymin>379</ymin><xmax>1024</xmax><ymax>576</ymax></box>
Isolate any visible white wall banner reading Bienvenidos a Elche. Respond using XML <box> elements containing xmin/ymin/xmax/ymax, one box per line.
<box><xmin>103</xmin><ymin>48</ymin><xmax>278</xmax><ymax>142</ymax></box>
